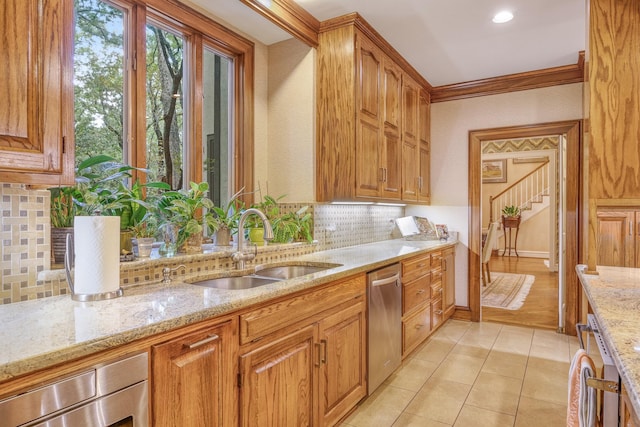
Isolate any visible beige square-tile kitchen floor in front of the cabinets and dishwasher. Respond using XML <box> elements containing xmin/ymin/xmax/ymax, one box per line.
<box><xmin>342</xmin><ymin>320</ymin><xmax>598</xmax><ymax>427</ymax></box>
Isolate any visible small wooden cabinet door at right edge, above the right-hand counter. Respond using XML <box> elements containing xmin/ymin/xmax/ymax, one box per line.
<box><xmin>596</xmin><ymin>209</ymin><xmax>635</xmax><ymax>267</ymax></box>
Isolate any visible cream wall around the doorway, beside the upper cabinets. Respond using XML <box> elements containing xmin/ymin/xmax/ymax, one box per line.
<box><xmin>406</xmin><ymin>83</ymin><xmax>582</xmax><ymax>306</ymax></box>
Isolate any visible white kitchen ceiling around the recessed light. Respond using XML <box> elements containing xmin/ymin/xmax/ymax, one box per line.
<box><xmin>185</xmin><ymin>0</ymin><xmax>586</xmax><ymax>86</ymax></box>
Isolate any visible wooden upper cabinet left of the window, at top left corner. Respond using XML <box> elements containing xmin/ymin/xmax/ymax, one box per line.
<box><xmin>0</xmin><ymin>0</ymin><xmax>74</xmax><ymax>184</ymax></box>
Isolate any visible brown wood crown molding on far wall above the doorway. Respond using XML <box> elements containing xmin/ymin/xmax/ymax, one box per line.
<box><xmin>431</xmin><ymin>51</ymin><xmax>585</xmax><ymax>103</ymax></box>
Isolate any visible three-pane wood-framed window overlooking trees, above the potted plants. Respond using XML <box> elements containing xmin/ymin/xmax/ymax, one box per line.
<box><xmin>74</xmin><ymin>0</ymin><xmax>253</xmax><ymax>201</ymax></box>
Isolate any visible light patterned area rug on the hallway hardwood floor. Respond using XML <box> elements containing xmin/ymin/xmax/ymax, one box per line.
<box><xmin>480</xmin><ymin>272</ymin><xmax>535</xmax><ymax>310</ymax></box>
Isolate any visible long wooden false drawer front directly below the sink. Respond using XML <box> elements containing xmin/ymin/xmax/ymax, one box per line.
<box><xmin>240</xmin><ymin>274</ymin><xmax>366</xmax><ymax>344</ymax></box>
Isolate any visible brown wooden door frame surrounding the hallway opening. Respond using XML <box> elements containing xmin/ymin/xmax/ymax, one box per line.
<box><xmin>468</xmin><ymin>120</ymin><xmax>582</xmax><ymax>334</ymax></box>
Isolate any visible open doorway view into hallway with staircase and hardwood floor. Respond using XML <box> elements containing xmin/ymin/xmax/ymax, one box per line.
<box><xmin>481</xmin><ymin>145</ymin><xmax>564</xmax><ymax>329</ymax></box>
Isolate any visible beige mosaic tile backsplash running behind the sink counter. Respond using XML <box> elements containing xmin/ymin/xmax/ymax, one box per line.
<box><xmin>0</xmin><ymin>184</ymin><xmax>404</xmax><ymax>304</ymax></box>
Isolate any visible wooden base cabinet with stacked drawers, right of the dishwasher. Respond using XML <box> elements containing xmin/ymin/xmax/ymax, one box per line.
<box><xmin>402</xmin><ymin>247</ymin><xmax>455</xmax><ymax>357</ymax></box>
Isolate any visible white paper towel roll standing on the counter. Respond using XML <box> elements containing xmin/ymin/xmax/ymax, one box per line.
<box><xmin>73</xmin><ymin>216</ymin><xmax>120</xmax><ymax>294</ymax></box>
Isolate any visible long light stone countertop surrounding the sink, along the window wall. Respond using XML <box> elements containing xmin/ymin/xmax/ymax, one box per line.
<box><xmin>0</xmin><ymin>239</ymin><xmax>457</xmax><ymax>382</ymax></box>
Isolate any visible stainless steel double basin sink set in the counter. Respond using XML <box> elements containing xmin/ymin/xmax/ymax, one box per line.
<box><xmin>192</xmin><ymin>263</ymin><xmax>341</xmax><ymax>290</ymax></box>
